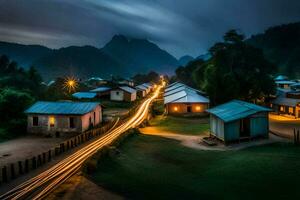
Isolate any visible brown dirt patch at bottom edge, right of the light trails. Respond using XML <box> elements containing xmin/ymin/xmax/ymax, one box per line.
<box><xmin>46</xmin><ymin>173</ymin><xmax>124</xmax><ymax>200</ymax></box>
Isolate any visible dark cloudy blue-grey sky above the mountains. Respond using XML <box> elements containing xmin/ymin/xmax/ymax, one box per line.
<box><xmin>0</xmin><ymin>0</ymin><xmax>300</xmax><ymax>57</ymax></box>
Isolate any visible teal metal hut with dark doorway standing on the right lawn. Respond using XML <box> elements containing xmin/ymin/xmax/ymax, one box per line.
<box><xmin>207</xmin><ymin>100</ymin><xmax>271</xmax><ymax>143</ymax></box>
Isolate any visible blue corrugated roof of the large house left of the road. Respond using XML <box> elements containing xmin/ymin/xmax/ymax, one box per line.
<box><xmin>25</xmin><ymin>101</ymin><xmax>99</xmax><ymax>115</ymax></box>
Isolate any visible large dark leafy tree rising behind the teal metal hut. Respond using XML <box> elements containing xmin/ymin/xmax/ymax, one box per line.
<box><xmin>194</xmin><ymin>30</ymin><xmax>276</xmax><ymax>105</ymax></box>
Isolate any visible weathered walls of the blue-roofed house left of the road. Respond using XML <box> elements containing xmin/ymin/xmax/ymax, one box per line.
<box><xmin>27</xmin><ymin>106</ymin><xmax>102</xmax><ymax>135</ymax></box>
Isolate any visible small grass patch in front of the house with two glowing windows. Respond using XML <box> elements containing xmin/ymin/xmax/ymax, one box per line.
<box><xmin>150</xmin><ymin>116</ymin><xmax>209</xmax><ymax>135</ymax></box>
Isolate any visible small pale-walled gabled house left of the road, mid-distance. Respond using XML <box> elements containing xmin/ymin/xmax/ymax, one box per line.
<box><xmin>110</xmin><ymin>86</ymin><xmax>136</xmax><ymax>102</ymax></box>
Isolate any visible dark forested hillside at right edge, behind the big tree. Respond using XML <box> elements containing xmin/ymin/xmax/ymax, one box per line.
<box><xmin>247</xmin><ymin>23</ymin><xmax>300</xmax><ymax>78</ymax></box>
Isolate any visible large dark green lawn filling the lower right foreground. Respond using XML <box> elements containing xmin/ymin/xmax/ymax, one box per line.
<box><xmin>92</xmin><ymin>135</ymin><xmax>300</xmax><ymax>200</ymax></box>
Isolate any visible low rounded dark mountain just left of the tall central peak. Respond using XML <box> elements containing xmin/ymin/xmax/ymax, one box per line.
<box><xmin>33</xmin><ymin>46</ymin><xmax>122</xmax><ymax>79</ymax></box>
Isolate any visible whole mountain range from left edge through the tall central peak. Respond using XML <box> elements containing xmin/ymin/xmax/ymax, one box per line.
<box><xmin>0</xmin><ymin>35</ymin><xmax>179</xmax><ymax>80</ymax></box>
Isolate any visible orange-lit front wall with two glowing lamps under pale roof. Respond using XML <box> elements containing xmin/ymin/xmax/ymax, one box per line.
<box><xmin>166</xmin><ymin>103</ymin><xmax>209</xmax><ymax>114</ymax></box>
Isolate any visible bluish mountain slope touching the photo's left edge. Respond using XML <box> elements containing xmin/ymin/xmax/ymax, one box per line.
<box><xmin>0</xmin><ymin>41</ymin><xmax>52</xmax><ymax>67</ymax></box>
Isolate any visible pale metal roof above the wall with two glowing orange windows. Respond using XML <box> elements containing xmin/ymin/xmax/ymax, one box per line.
<box><xmin>164</xmin><ymin>89</ymin><xmax>209</xmax><ymax>104</ymax></box>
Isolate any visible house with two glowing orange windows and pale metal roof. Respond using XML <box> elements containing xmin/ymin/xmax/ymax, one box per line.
<box><xmin>164</xmin><ymin>87</ymin><xmax>209</xmax><ymax>115</ymax></box>
